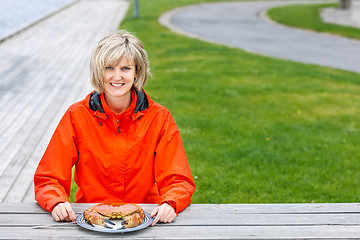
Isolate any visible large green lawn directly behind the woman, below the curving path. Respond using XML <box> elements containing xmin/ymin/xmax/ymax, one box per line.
<box><xmin>72</xmin><ymin>0</ymin><xmax>360</xmax><ymax>203</ymax></box>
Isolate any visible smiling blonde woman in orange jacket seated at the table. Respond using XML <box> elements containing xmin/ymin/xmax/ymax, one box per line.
<box><xmin>34</xmin><ymin>31</ymin><xmax>195</xmax><ymax>225</ymax></box>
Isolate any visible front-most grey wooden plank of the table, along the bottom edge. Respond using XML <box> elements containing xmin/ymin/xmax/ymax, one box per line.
<box><xmin>0</xmin><ymin>226</ymin><xmax>360</xmax><ymax>239</ymax></box>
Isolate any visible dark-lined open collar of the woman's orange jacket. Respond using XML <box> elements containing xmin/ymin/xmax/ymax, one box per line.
<box><xmin>89</xmin><ymin>89</ymin><xmax>149</xmax><ymax>120</ymax></box>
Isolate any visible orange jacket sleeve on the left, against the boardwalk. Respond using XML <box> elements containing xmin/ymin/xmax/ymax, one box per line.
<box><xmin>34</xmin><ymin>110</ymin><xmax>78</xmax><ymax>212</ymax></box>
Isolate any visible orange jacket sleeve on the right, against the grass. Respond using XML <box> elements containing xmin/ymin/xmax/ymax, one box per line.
<box><xmin>154</xmin><ymin>113</ymin><xmax>195</xmax><ymax>213</ymax></box>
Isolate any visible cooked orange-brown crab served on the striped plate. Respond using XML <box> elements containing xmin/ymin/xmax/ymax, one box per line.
<box><xmin>84</xmin><ymin>203</ymin><xmax>145</xmax><ymax>228</ymax></box>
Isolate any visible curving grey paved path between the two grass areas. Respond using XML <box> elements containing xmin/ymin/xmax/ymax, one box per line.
<box><xmin>160</xmin><ymin>1</ymin><xmax>360</xmax><ymax>73</ymax></box>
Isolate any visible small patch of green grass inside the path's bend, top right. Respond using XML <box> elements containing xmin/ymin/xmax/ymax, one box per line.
<box><xmin>267</xmin><ymin>3</ymin><xmax>360</xmax><ymax>40</ymax></box>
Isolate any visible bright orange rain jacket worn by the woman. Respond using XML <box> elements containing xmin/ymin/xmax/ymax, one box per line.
<box><xmin>34</xmin><ymin>91</ymin><xmax>195</xmax><ymax>213</ymax></box>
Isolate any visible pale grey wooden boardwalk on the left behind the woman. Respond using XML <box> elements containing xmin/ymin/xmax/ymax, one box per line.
<box><xmin>0</xmin><ymin>0</ymin><xmax>129</xmax><ymax>202</ymax></box>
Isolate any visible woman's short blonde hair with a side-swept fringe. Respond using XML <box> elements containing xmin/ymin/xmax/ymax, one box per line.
<box><xmin>90</xmin><ymin>30</ymin><xmax>150</xmax><ymax>92</ymax></box>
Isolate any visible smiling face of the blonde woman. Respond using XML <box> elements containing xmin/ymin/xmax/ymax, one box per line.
<box><xmin>104</xmin><ymin>58</ymin><xmax>137</xmax><ymax>102</ymax></box>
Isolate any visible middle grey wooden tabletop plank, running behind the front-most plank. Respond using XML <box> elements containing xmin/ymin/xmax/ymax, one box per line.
<box><xmin>0</xmin><ymin>212</ymin><xmax>360</xmax><ymax>227</ymax></box>
